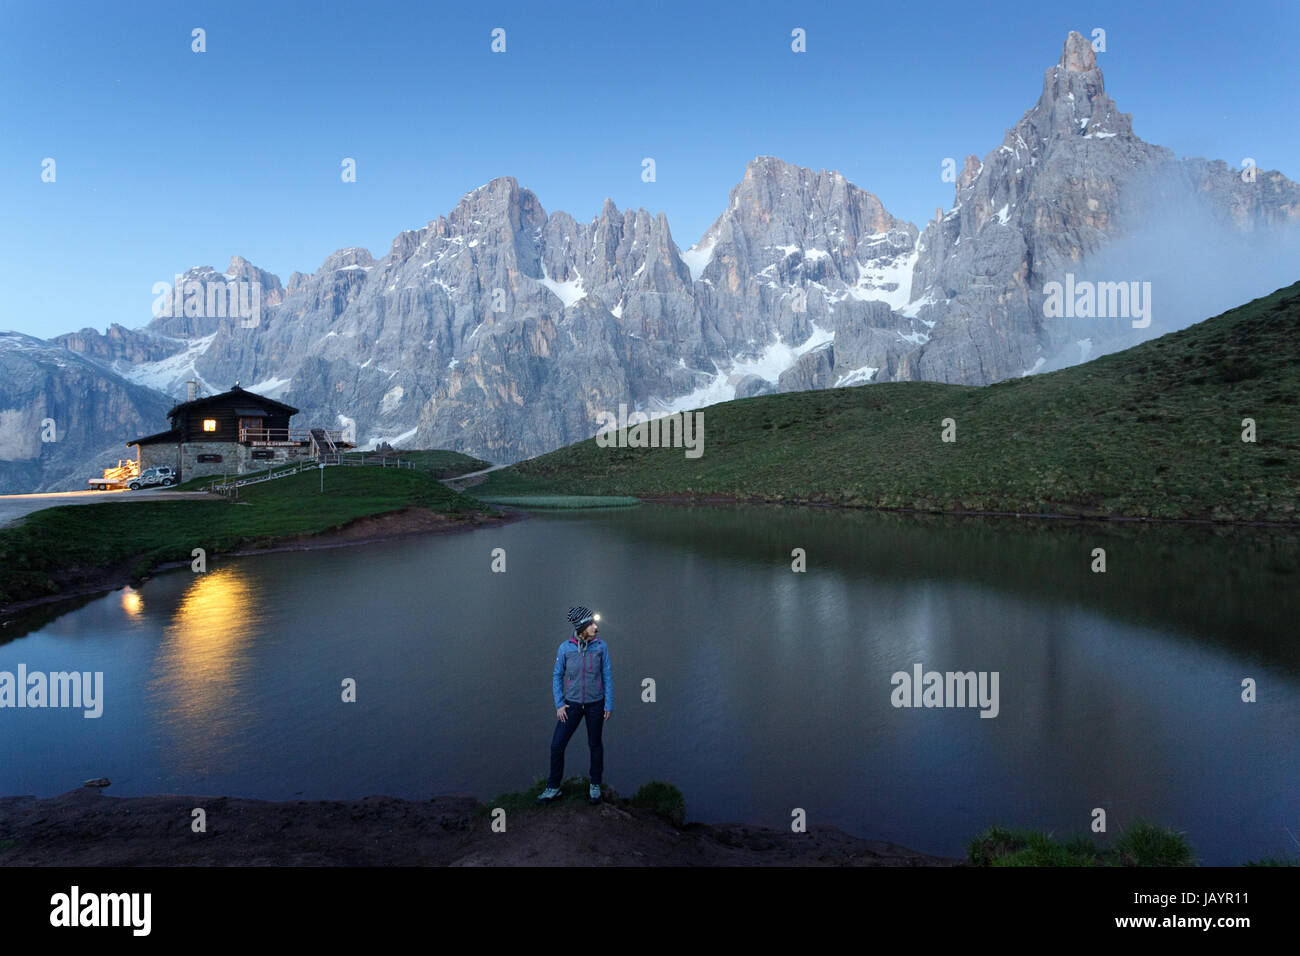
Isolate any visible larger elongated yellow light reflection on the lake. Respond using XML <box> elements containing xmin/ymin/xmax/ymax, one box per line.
<box><xmin>153</xmin><ymin>567</ymin><xmax>263</xmax><ymax>770</ymax></box>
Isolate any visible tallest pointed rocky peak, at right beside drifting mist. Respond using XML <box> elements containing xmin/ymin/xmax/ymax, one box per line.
<box><xmin>904</xmin><ymin>31</ymin><xmax>1300</xmax><ymax>385</ymax></box>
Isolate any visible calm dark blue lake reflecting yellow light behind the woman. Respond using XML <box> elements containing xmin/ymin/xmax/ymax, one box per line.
<box><xmin>0</xmin><ymin>505</ymin><xmax>1300</xmax><ymax>865</ymax></box>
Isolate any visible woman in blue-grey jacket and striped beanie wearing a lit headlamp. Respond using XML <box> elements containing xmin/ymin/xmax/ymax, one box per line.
<box><xmin>537</xmin><ymin>605</ymin><xmax>614</xmax><ymax>804</ymax></box>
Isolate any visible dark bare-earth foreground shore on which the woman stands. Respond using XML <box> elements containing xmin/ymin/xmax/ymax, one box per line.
<box><xmin>0</xmin><ymin>786</ymin><xmax>969</xmax><ymax>866</ymax></box>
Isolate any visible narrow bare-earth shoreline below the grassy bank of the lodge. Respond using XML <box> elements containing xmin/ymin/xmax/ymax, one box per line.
<box><xmin>0</xmin><ymin>505</ymin><xmax>528</xmax><ymax>618</ymax></box>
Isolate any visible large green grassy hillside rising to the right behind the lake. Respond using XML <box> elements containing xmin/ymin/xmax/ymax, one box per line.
<box><xmin>475</xmin><ymin>282</ymin><xmax>1300</xmax><ymax>523</ymax></box>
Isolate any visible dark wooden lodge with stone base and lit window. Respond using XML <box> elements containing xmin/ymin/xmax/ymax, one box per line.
<box><xmin>126</xmin><ymin>384</ymin><xmax>352</xmax><ymax>481</ymax></box>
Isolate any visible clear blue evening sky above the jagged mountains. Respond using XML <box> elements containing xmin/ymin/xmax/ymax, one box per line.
<box><xmin>0</xmin><ymin>0</ymin><xmax>1300</xmax><ymax>337</ymax></box>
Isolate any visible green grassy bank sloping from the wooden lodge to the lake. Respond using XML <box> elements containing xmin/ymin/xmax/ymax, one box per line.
<box><xmin>0</xmin><ymin>467</ymin><xmax>484</xmax><ymax>606</ymax></box>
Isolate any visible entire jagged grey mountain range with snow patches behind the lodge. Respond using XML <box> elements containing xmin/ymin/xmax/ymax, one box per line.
<box><xmin>0</xmin><ymin>33</ymin><xmax>1300</xmax><ymax>492</ymax></box>
